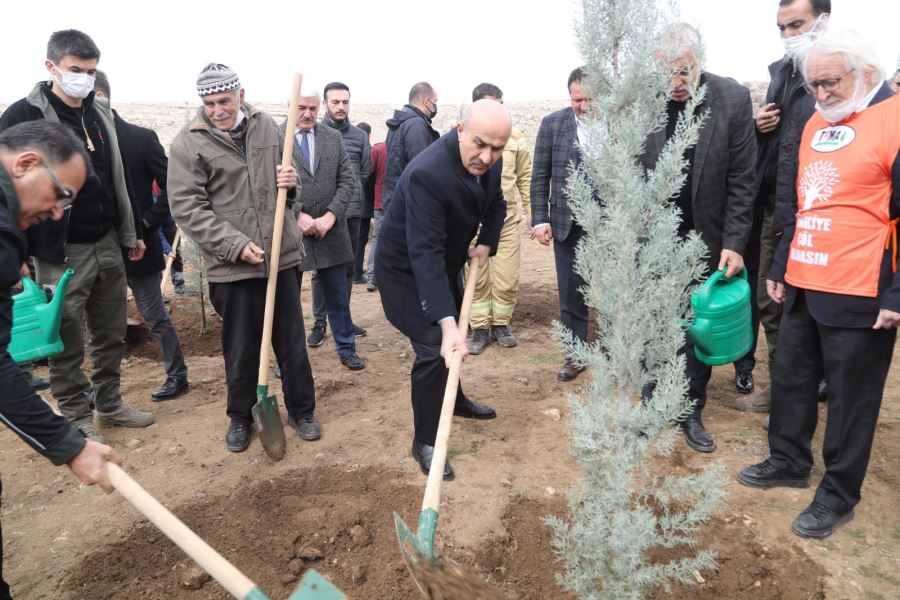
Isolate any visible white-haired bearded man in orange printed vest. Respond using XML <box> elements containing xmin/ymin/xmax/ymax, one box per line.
<box><xmin>738</xmin><ymin>29</ymin><xmax>900</xmax><ymax>538</ymax></box>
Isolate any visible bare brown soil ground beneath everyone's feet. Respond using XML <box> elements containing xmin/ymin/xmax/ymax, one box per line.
<box><xmin>0</xmin><ymin>227</ymin><xmax>900</xmax><ymax>600</ymax></box>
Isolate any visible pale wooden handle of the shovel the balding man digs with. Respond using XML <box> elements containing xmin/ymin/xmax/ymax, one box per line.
<box><xmin>422</xmin><ymin>258</ymin><xmax>478</xmax><ymax>511</ymax></box>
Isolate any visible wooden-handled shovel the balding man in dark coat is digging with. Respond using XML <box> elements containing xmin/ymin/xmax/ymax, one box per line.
<box><xmin>394</xmin><ymin>258</ymin><xmax>498</xmax><ymax>599</ymax></box>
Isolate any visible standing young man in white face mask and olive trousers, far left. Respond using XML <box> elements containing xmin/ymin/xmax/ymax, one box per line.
<box><xmin>0</xmin><ymin>29</ymin><xmax>153</xmax><ymax>441</ymax></box>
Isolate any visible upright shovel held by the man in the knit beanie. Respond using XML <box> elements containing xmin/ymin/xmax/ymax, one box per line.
<box><xmin>253</xmin><ymin>73</ymin><xmax>303</xmax><ymax>460</ymax></box>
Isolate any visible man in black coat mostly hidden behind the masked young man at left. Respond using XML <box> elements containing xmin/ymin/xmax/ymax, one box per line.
<box><xmin>94</xmin><ymin>71</ymin><xmax>190</xmax><ymax>402</ymax></box>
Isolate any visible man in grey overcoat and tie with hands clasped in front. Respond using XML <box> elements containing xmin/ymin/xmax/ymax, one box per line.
<box><xmin>281</xmin><ymin>90</ymin><xmax>366</xmax><ymax>371</ymax></box>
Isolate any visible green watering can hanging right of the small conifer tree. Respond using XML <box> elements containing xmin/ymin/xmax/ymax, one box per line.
<box><xmin>685</xmin><ymin>269</ymin><xmax>753</xmax><ymax>366</ymax></box>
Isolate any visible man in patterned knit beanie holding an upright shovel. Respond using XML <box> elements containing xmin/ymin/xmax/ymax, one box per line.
<box><xmin>168</xmin><ymin>63</ymin><xmax>321</xmax><ymax>452</ymax></box>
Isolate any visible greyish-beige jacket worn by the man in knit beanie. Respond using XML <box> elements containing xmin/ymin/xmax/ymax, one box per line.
<box><xmin>166</xmin><ymin>104</ymin><xmax>300</xmax><ymax>283</ymax></box>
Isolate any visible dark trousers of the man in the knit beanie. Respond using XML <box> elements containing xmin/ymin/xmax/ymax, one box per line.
<box><xmin>209</xmin><ymin>268</ymin><xmax>316</xmax><ymax>423</ymax></box>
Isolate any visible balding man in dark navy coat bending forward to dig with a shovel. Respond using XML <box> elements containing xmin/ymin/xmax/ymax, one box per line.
<box><xmin>375</xmin><ymin>100</ymin><xmax>512</xmax><ymax>480</ymax></box>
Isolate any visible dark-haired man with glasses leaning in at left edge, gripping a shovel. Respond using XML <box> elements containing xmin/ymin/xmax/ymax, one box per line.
<box><xmin>0</xmin><ymin>120</ymin><xmax>121</xmax><ymax>600</ymax></box>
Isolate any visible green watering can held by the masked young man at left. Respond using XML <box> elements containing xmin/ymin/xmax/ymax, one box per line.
<box><xmin>7</xmin><ymin>269</ymin><xmax>74</xmax><ymax>364</ymax></box>
